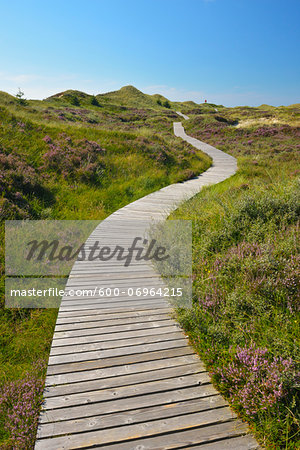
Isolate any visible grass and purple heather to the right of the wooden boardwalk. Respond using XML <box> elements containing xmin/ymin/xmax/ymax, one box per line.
<box><xmin>171</xmin><ymin>107</ymin><xmax>300</xmax><ymax>449</ymax></box>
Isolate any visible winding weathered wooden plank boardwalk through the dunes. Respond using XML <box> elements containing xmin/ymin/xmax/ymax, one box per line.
<box><xmin>35</xmin><ymin>122</ymin><xmax>258</xmax><ymax>450</ymax></box>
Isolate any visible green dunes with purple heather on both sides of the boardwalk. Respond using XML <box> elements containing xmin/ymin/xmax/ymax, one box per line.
<box><xmin>0</xmin><ymin>86</ymin><xmax>300</xmax><ymax>449</ymax></box>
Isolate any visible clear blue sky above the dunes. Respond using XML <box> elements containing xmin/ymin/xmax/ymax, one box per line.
<box><xmin>0</xmin><ymin>0</ymin><xmax>300</xmax><ymax>106</ymax></box>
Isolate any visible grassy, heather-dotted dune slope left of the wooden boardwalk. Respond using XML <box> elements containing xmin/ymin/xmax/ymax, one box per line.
<box><xmin>0</xmin><ymin>88</ymin><xmax>210</xmax><ymax>450</ymax></box>
